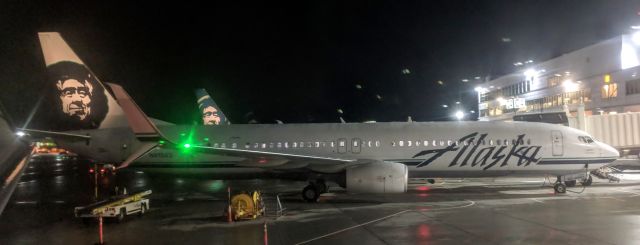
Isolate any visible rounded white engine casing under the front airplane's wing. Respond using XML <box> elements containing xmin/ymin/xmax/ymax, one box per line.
<box><xmin>346</xmin><ymin>162</ymin><xmax>409</xmax><ymax>193</ymax></box>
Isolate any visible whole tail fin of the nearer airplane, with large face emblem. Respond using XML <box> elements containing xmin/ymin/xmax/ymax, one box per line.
<box><xmin>36</xmin><ymin>32</ymin><xmax>128</xmax><ymax>131</ymax></box>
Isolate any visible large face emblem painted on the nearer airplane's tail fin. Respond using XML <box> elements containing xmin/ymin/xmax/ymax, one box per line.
<box><xmin>47</xmin><ymin>61</ymin><xmax>108</xmax><ymax>130</ymax></box>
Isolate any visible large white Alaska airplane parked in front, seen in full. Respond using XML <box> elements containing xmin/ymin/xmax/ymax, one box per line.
<box><xmin>10</xmin><ymin>32</ymin><xmax>619</xmax><ymax>201</ymax></box>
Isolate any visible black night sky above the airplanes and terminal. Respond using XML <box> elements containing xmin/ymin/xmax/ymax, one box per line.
<box><xmin>0</xmin><ymin>0</ymin><xmax>640</xmax><ymax>124</ymax></box>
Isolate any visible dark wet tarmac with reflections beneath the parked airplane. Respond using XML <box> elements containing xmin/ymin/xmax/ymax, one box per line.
<box><xmin>0</xmin><ymin>156</ymin><xmax>640</xmax><ymax>244</ymax></box>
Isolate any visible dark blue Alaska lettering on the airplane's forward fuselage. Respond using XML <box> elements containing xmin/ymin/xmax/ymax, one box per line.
<box><xmin>413</xmin><ymin>132</ymin><xmax>542</xmax><ymax>170</ymax></box>
